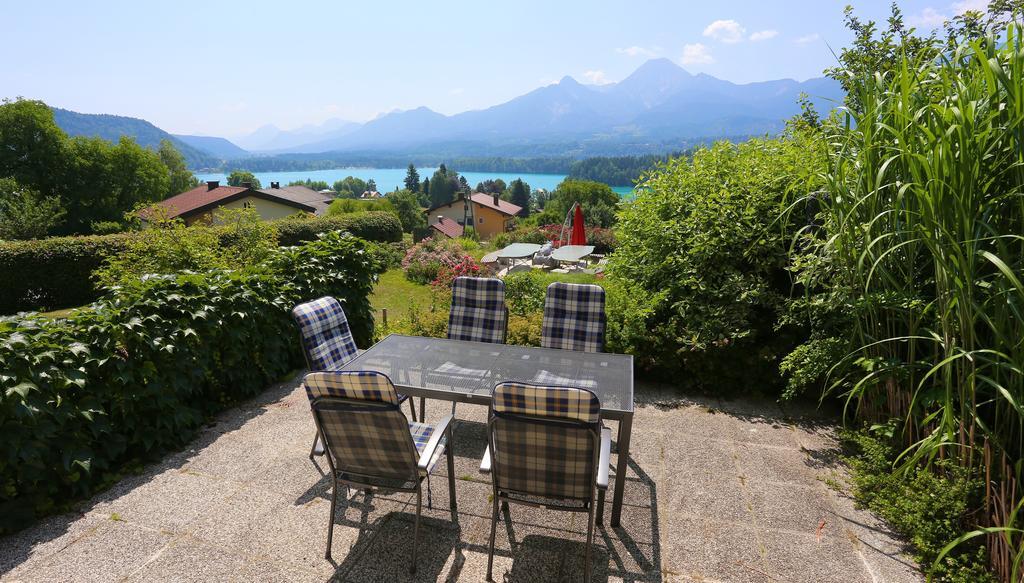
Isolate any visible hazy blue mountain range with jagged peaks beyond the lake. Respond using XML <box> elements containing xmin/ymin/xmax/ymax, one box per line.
<box><xmin>51</xmin><ymin>58</ymin><xmax>843</xmax><ymax>164</ymax></box>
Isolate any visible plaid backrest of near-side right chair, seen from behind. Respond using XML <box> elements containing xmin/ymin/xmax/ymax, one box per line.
<box><xmin>487</xmin><ymin>382</ymin><xmax>601</xmax><ymax>500</ymax></box>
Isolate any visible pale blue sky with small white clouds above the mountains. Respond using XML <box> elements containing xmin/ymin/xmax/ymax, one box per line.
<box><xmin>0</xmin><ymin>0</ymin><xmax>984</xmax><ymax>137</ymax></box>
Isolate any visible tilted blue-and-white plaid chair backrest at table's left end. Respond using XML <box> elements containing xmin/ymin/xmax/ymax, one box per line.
<box><xmin>292</xmin><ymin>296</ymin><xmax>357</xmax><ymax>371</ymax></box>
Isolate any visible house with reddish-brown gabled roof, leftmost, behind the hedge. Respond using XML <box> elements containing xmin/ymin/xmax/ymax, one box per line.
<box><xmin>157</xmin><ymin>180</ymin><xmax>333</xmax><ymax>224</ymax></box>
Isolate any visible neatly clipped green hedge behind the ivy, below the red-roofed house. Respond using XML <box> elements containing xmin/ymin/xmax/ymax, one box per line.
<box><xmin>0</xmin><ymin>211</ymin><xmax>401</xmax><ymax>314</ymax></box>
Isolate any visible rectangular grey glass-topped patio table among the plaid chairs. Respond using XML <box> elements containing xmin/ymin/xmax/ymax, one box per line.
<box><xmin>342</xmin><ymin>334</ymin><xmax>633</xmax><ymax>527</ymax></box>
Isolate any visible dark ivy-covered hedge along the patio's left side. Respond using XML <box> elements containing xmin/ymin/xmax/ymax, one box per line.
<box><xmin>0</xmin><ymin>233</ymin><xmax>382</xmax><ymax>533</ymax></box>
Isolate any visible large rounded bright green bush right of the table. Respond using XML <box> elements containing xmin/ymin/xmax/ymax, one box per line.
<box><xmin>609</xmin><ymin>132</ymin><xmax>824</xmax><ymax>390</ymax></box>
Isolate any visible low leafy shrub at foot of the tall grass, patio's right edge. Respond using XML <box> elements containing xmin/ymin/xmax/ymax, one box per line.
<box><xmin>843</xmin><ymin>431</ymin><xmax>996</xmax><ymax>583</ymax></box>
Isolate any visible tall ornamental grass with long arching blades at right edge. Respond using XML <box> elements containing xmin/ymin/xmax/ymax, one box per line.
<box><xmin>799</xmin><ymin>25</ymin><xmax>1024</xmax><ymax>581</ymax></box>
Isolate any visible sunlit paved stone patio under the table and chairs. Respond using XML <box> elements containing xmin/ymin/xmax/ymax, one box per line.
<box><xmin>0</xmin><ymin>380</ymin><xmax>923</xmax><ymax>583</ymax></box>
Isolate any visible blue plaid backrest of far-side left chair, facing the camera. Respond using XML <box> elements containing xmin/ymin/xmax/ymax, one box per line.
<box><xmin>447</xmin><ymin>278</ymin><xmax>509</xmax><ymax>344</ymax></box>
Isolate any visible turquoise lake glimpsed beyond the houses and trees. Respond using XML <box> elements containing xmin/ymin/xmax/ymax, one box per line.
<box><xmin>196</xmin><ymin>168</ymin><xmax>633</xmax><ymax>196</ymax></box>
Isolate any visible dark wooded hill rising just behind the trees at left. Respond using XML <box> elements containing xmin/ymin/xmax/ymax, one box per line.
<box><xmin>52</xmin><ymin>108</ymin><xmax>221</xmax><ymax>169</ymax></box>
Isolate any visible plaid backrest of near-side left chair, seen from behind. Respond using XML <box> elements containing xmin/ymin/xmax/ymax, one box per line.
<box><xmin>303</xmin><ymin>371</ymin><xmax>419</xmax><ymax>482</ymax></box>
